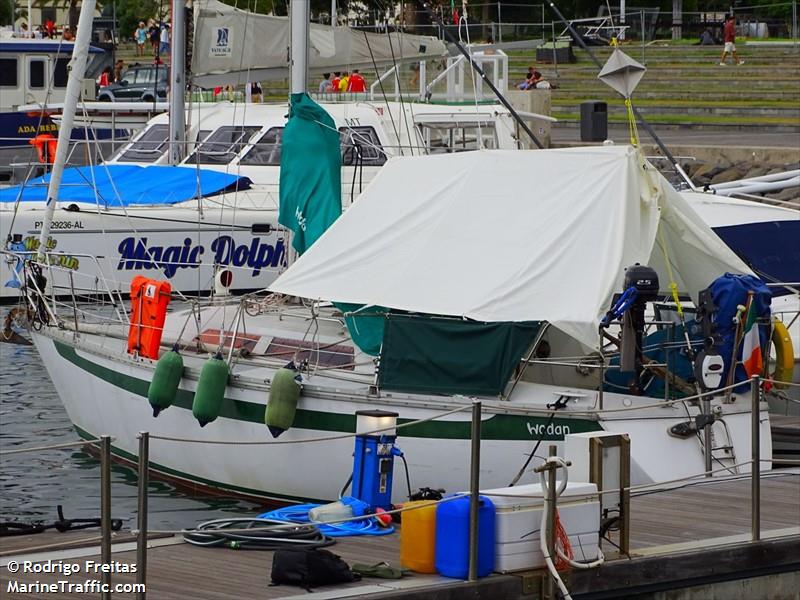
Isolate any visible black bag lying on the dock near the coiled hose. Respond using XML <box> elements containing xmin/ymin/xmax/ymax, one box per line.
<box><xmin>271</xmin><ymin>548</ymin><xmax>361</xmax><ymax>590</ymax></box>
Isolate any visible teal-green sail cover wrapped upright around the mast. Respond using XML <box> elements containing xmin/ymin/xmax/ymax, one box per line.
<box><xmin>278</xmin><ymin>94</ymin><xmax>342</xmax><ymax>254</ymax></box>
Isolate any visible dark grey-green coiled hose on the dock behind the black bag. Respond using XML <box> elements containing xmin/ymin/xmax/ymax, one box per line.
<box><xmin>183</xmin><ymin>518</ymin><xmax>336</xmax><ymax>550</ymax></box>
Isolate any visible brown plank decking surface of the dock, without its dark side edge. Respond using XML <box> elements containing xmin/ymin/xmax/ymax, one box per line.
<box><xmin>0</xmin><ymin>470</ymin><xmax>800</xmax><ymax>600</ymax></box>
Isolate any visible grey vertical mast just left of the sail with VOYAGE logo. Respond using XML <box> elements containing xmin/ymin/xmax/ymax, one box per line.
<box><xmin>169</xmin><ymin>0</ymin><xmax>186</xmax><ymax>165</ymax></box>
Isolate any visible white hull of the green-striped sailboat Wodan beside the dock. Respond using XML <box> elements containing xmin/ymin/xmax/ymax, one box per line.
<box><xmin>33</xmin><ymin>329</ymin><xmax>772</xmax><ymax>501</ymax></box>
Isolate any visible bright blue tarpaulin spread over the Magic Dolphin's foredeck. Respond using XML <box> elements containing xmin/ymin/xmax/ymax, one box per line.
<box><xmin>0</xmin><ymin>165</ymin><xmax>250</xmax><ymax>207</ymax></box>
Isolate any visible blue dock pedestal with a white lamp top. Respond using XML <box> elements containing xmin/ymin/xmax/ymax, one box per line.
<box><xmin>352</xmin><ymin>410</ymin><xmax>402</xmax><ymax>510</ymax></box>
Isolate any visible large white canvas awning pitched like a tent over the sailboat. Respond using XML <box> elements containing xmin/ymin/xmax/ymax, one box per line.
<box><xmin>269</xmin><ymin>146</ymin><xmax>750</xmax><ymax>347</ymax></box>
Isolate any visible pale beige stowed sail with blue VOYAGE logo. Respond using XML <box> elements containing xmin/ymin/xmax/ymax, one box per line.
<box><xmin>192</xmin><ymin>0</ymin><xmax>447</xmax><ymax>87</ymax></box>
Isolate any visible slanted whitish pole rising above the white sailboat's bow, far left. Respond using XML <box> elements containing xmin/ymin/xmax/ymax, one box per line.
<box><xmin>36</xmin><ymin>0</ymin><xmax>96</xmax><ymax>262</ymax></box>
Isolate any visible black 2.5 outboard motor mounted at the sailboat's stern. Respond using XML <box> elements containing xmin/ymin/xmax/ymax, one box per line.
<box><xmin>620</xmin><ymin>263</ymin><xmax>658</xmax><ymax>394</ymax></box>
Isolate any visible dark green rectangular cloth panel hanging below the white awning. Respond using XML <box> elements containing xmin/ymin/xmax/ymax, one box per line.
<box><xmin>378</xmin><ymin>314</ymin><xmax>542</xmax><ymax>396</ymax></box>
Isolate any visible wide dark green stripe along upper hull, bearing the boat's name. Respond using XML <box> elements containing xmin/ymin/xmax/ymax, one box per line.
<box><xmin>53</xmin><ymin>340</ymin><xmax>602</xmax><ymax>441</ymax></box>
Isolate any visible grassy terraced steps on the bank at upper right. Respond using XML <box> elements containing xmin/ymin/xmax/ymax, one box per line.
<box><xmin>509</xmin><ymin>43</ymin><xmax>800</xmax><ymax>132</ymax></box>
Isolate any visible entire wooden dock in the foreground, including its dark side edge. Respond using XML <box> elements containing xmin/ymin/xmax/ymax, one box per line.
<box><xmin>0</xmin><ymin>469</ymin><xmax>800</xmax><ymax>600</ymax></box>
